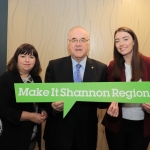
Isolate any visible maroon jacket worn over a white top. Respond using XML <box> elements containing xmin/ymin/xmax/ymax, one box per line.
<box><xmin>102</xmin><ymin>55</ymin><xmax>150</xmax><ymax>136</ymax></box>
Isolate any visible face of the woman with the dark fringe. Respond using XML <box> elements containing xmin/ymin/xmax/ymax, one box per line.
<box><xmin>17</xmin><ymin>54</ymin><xmax>36</xmax><ymax>74</ymax></box>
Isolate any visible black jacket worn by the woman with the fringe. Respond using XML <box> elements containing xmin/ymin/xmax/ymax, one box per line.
<box><xmin>0</xmin><ymin>71</ymin><xmax>42</xmax><ymax>150</ymax></box>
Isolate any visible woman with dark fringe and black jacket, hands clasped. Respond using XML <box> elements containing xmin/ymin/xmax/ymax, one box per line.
<box><xmin>0</xmin><ymin>44</ymin><xmax>47</xmax><ymax>150</ymax></box>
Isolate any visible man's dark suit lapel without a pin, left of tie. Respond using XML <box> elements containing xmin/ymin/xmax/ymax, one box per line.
<box><xmin>63</xmin><ymin>56</ymin><xmax>73</xmax><ymax>82</ymax></box>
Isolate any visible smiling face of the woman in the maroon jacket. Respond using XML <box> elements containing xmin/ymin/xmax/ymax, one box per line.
<box><xmin>115</xmin><ymin>31</ymin><xmax>134</xmax><ymax>56</ymax></box>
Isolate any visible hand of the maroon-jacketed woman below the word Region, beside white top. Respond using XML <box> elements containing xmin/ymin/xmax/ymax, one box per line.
<box><xmin>107</xmin><ymin>102</ymin><xmax>119</xmax><ymax>117</ymax></box>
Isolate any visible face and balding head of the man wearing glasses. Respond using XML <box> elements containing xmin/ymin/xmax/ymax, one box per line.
<box><xmin>68</xmin><ymin>28</ymin><xmax>89</xmax><ymax>62</ymax></box>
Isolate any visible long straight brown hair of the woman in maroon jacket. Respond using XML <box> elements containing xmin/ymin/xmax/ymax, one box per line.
<box><xmin>112</xmin><ymin>27</ymin><xmax>143</xmax><ymax>81</ymax></box>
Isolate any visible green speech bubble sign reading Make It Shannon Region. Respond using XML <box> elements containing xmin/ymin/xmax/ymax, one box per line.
<box><xmin>15</xmin><ymin>82</ymin><xmax>150</xmax><ymax>117</ymax></box>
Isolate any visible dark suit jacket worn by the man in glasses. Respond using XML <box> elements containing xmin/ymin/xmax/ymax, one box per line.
<box><xmin>44</xmin><ymin>56</ymin><xmax>107</xmax><ymax>150</ymax></box>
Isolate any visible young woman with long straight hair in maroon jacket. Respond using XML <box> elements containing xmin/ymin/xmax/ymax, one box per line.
<box><xmin>102</xmin><ymin>27</ymin><xmax>150</xmax><ymax>150</ymax></box>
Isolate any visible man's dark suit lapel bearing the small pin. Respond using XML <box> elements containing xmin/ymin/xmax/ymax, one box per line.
<box><xmin>83</xmin><ymin>57</ymin><xmax>95</xmax><ymax>82</ymax></box>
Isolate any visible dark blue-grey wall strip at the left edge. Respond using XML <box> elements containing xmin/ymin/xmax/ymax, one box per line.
<box><xmin>0</xmin><ymin>0</ymin><xmax>8</xmax><ymax>75</ymax></box>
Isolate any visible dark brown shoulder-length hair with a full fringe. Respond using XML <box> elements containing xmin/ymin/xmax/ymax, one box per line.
<box><xmin>7</xmin><ymin>43</ymin><xmax>42</xmax><ymax>76</ymax></box>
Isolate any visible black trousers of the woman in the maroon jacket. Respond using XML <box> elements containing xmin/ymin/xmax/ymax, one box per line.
<box><xmin>105</xmin><ymin>119</ymin><xmax>150</xmax><ymax>150</ymax></box>
